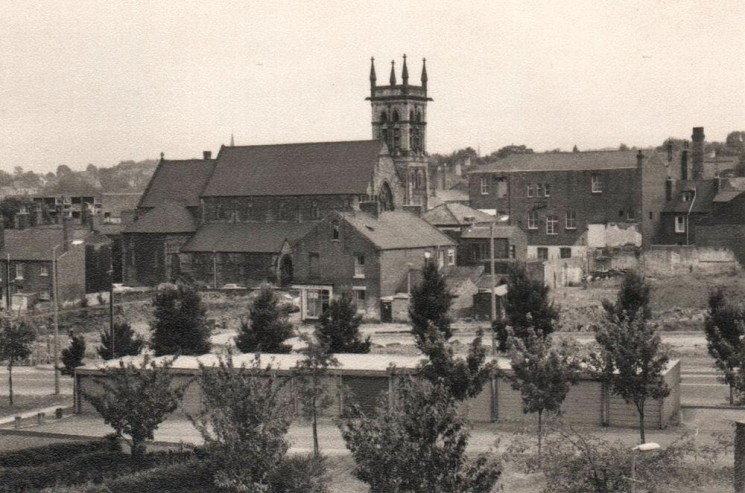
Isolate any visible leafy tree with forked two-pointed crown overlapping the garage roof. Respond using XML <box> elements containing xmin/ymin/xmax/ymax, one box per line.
<box><xmin>421</xmin><ymin>325</ymin><xmax>494</xmax><ymax>401</ymax></box>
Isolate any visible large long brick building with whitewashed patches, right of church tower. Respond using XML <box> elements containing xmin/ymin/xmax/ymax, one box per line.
<box><xmin>469</xmin><ymin>151</ymin><xmax>677</xmax><ymax>259</ymax></box>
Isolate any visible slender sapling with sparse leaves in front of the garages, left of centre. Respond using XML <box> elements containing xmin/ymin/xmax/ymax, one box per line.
<box><xmin>295</xmin><ymin>332</ymin><xmax>339</xmax><ymax>458</ymax></box>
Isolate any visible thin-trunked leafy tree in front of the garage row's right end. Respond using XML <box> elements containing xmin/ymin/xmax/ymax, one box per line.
<box><xmin>592</xmin><ymin>310</ymin><xmax>670</xmax><ymax>443</ymax></box>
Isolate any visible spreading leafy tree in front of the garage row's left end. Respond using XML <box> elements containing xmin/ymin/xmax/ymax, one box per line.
<box><xmin>82</xmin><ymin>356</ymin><xmax>189</xmax><ymax>460</ymax></box>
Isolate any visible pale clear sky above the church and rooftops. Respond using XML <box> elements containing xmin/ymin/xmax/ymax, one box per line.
<box><xmin>0</xmin><ymin>0</ymin><xmax>745</xmax><ymax>172</ymax></box>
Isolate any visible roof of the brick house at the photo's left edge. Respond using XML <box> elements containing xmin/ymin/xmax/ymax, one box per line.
<box><xmin>0</xmin><ymin>225</ymin><xmax>91</xmax><ymax>261</ymax></box>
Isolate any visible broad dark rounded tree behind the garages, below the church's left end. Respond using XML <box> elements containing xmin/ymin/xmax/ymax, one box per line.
<box><xmin>149</xmin><ymin>285</ymin><xmax>210</xmax><ymax>356</ymax></box>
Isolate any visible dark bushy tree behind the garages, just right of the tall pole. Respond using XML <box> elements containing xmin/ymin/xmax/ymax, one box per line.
<box><xmin>492</xmin><ymin>266</ymin><xmax>559</xmax><ymax>351</ymax></box>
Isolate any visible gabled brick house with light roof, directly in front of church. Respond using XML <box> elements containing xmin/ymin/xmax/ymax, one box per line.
<box><xmin>292</xmin><ymin>203</ymin><xmax>456</xmax><ymax>319</ymax></box>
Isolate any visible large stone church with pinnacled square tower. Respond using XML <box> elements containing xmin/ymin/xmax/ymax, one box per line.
<box><xmin>122</xmin><ymin>55</ymin><xmax>447</xmax><ymax>294</ymax></box>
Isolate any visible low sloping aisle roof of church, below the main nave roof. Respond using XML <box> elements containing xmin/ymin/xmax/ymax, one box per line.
<box><xmin>181</xmin><ymin>222</ymin><xmax>317</xmax><ymax>253</ymax></box>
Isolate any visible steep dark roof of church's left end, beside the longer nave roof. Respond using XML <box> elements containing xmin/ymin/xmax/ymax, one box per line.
<box><xmin>138</xmin><ymin>159</ymin><xmax>215</xmax><ymax>207</ymax></box>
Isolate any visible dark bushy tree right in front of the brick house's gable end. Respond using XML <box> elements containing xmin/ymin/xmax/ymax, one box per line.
<box><xmin>316</xmin><ymin>293</ymin><xmax>370</xmax><ymax>353</ymax></box>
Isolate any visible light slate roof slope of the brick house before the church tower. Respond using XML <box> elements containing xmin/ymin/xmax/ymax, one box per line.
<box><xmin>336</xmin><ymin>211</ymin><xmax>455</xmax><ymax>250</ymax></box>
